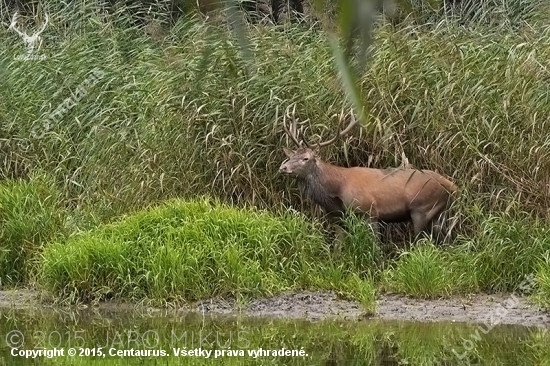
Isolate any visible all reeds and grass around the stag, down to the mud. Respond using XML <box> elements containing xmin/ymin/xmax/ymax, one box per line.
<box><xmin>0</xmin><ymin>1</ymin><xmax>550</xmax><ymax>305</ymax></box>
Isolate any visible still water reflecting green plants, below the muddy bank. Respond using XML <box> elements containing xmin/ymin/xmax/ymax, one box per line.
<box><xmin>0</xmin><ymin>309</ymin><xmax>550</xmax><ymax>365</ymax></box>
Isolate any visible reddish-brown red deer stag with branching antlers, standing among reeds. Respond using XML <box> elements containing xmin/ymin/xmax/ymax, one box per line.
<box><xmin>279</xmin><ymin>104</ymin><xmax>457</xmax><ymax>237</ymax></box>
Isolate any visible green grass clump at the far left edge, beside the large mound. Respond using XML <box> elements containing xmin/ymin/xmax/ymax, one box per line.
<box><xmin>0</xmin><ymin>174</ymin><xmax>64</xmax><ymax>288</ymax></box>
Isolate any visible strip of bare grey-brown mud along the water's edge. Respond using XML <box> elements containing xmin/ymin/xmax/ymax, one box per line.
<box><xmin>0</xmin><ymin>290</ymin><xmax>550</xmax><ymax>328</ymax></box>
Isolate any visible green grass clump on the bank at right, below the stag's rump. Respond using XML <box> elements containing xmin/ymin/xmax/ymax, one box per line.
<box><xmin>384</xmin><ymin>214</ymin><xmax>550</xmax><ymax>303</ymax></box>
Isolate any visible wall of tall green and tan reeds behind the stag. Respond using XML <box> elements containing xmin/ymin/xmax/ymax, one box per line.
<box><xmin>0</xmin><ymin>5</ymin><xmax>550</xmax><ymax>222</ymax></box>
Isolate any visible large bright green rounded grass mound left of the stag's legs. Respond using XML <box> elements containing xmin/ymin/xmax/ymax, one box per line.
<box><xmin>37</xmin><ymin>200</ymin><xmax>372</xmax><ymax>303</ymax></box>
